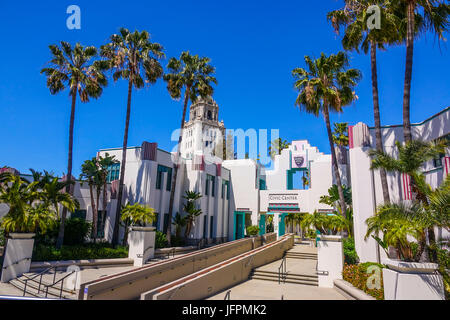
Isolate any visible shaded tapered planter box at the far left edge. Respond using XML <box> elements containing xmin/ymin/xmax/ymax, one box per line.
<box><xmin>0</xmin><ymin>233</ymin><xmax>36</xmax><ymax>282</ymax></box>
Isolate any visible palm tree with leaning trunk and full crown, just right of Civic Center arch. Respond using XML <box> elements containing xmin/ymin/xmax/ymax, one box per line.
<box><xmin>292</xmin><ymin>52</ymin><xmax>361</xmax><ymax>214</ymax></box>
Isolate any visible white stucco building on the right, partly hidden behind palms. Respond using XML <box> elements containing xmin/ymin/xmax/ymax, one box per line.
<box><xmin>349</xmin><ymin>108</ymin><xmax>450</xmax><ymax>262</ymax></box>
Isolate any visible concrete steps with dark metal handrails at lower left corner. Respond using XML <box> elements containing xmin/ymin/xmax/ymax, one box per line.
<box><xmin>9</xmin><ymin>272</ymin><xmax>77</xmax><ymax>300</ymax></box>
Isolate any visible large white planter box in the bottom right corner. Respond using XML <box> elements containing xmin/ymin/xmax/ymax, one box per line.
<box><xmin>382</xmin><ymin>259</ymin><xmax>445</xmax><ymax>300</ymax></box>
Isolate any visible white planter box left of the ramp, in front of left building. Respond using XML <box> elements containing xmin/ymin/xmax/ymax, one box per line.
<box><xmin>128</xmin><ymin>227</ymin><xmax>156</xmax><ymax>267</ymax></box>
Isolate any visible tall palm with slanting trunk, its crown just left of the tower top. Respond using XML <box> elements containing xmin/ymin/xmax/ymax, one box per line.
<box><xmin>164</xmin><ymin>51</ymin><xmax>217</xmax><ymax>246</ymax></box>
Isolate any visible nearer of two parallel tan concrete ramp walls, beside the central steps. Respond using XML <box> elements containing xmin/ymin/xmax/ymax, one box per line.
<box><xmin>141</xmin><ymin>235</ymin><xmax>294</xmax><ymax>300</ymax></box>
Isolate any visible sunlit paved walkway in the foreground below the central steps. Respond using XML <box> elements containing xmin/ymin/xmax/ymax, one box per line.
<box><xmin>207</xmin><ymin>279</ymin><xmax>346</xmax><ymax>300</ymax></box>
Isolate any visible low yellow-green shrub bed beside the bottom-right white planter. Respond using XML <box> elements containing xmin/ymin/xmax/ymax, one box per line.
<box><xmin>342</xmin><ymin>262</ymin><xmax>385</xmax><ymax>300</ymax></box>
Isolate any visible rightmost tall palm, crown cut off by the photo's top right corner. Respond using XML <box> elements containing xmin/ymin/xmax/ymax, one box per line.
<box><xmin>400</xmin><ymin>0</ymin><xmax>450</xmax><ymax>142</ymax></box>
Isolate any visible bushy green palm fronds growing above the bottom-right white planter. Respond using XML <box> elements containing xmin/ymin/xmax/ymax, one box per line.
<box><xmin>366</xmin><ymin>140</ymin><xmax>450</xmax><ymax>261</ymax></box>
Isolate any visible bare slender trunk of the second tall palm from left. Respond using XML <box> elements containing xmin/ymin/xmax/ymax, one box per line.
<box><xmin>112</xmin><ymin>78</ymin><xmax>133</xmax><ymax>246</ymax></box>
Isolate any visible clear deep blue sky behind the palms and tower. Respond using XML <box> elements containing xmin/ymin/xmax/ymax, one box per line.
<box><xmin>0</xmin><ymin>0</ymin><xmax>450</xmax><ymax>176</ymax></box>
